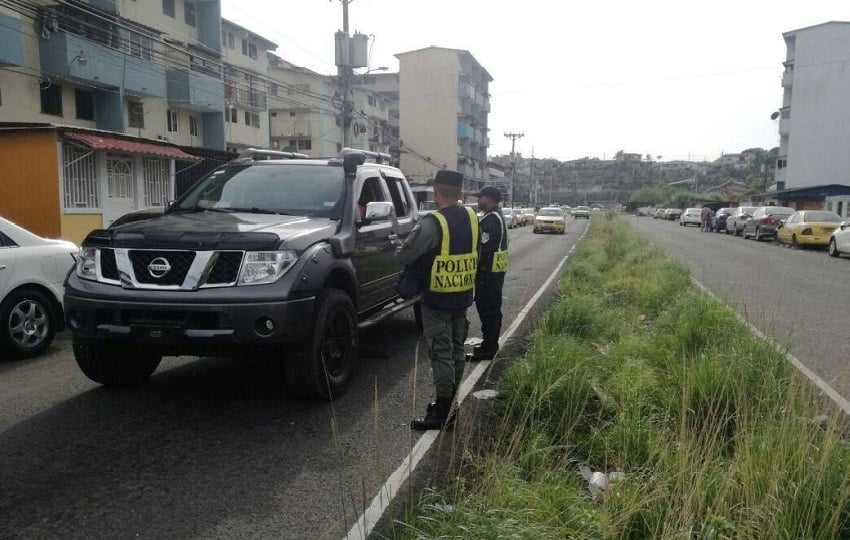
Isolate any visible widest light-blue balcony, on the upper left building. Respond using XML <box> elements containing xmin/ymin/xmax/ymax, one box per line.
<box><xmin>39</xmin><ymin>31</ymin><xmax>166</xmax><ymax>97</ymax></box>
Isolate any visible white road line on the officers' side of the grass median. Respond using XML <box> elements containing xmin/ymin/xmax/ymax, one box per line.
<box><xmin>345</xmin><ymin>227</ymin><xmax>590</xmax><ymax>540</ymax></box>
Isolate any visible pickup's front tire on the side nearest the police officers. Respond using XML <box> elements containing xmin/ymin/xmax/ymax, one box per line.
<box><xmin>285</xmin><ymin>289</ymin><xmax>352</xmax><ymax>401</ymax></box>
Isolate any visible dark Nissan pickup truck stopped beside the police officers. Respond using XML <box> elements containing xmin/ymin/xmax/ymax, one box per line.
<box><xmin>64</xmin><ymin>151</ymin><xmax>418</xmax><ymax>399</ymax></box>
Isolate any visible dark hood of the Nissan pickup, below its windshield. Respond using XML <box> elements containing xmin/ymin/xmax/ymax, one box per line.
<box><xmin>102</xmin><ymin>211</ymin><xmax>339</xmax><ymax>251</ymax></box>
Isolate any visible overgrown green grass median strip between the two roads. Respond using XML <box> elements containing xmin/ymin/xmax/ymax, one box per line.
<box><xmin>394</xmin><ymin>216</ymin><xmax>850</xmax><ymax>539</ymax></box>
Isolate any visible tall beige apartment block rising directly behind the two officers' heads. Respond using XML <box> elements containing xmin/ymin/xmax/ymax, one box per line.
<box><xmin>396</xmin><ymin>47</ymin><xmax>493</xmax><ymax>191</ymax></box>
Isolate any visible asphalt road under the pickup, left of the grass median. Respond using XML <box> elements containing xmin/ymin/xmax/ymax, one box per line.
<box><xmin>0</xmin><ymin>219</ymin><xmax>588</xmax><ymax>539</ymax></box>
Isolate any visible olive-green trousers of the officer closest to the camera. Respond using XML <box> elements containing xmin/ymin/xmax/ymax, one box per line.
<box><xmin>422</xmin><ymin>305</ymin><xmax>469</xmax><ymax>399</ymax></box>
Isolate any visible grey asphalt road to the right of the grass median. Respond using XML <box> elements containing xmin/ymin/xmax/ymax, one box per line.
<box><xmin>628</xmin><ymin>217</ymin><xmax>850</xmax><ymax>398</ymax></box>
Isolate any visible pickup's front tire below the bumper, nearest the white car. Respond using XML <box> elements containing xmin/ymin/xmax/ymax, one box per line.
<box><xmin>74</xmin><ymin>336</ymin><xmax>162</xmax><ymax>386</ymax></box>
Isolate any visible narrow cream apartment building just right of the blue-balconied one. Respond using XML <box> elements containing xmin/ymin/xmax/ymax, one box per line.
<box><xmin>221</xmin><ymin>19</ymin><xmax>277</xmax><ymax>152</ymax></box>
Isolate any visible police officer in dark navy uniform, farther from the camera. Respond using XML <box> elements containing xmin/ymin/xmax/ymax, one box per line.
<box><xmin>468</xmin><ymin>186</ymin><xmax>508</xmax><ymax>361</ymax></box>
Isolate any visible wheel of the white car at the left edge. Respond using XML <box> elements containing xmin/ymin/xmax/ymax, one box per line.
<box><xmin>0</xmin><ymin>289</ymin><xmax>56</xmax><ymax>358</ymax></box>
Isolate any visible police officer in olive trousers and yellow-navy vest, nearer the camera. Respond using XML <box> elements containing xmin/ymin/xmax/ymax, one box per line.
<box><xmin>396</xmin><ymin>170</ymin><xmax>479</xmax><ymax>431</ymax></box>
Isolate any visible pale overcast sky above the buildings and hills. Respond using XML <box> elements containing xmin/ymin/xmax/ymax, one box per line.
<box><xmin>222</xmin><ymin>0</ymin><xmax>850</xmax><ymax>161</ymax></box>
